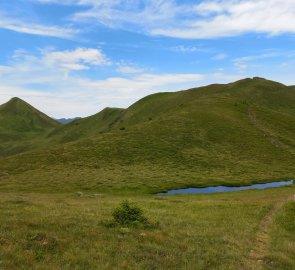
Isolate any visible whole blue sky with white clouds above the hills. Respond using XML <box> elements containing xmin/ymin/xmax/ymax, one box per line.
<box><xmin>0</xmin><ymin>0</ymin><xmax>295</xmax><ymax>118</ymax></box>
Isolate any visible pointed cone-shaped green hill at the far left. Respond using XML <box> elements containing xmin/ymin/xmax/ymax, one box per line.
<box><xmin>0</xmin><ymin>97</ymin><xmax>60</xmax><ymax>156</ymax></box>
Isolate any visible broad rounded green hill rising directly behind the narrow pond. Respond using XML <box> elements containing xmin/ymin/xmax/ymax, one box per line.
<box><xmin>0</xmin><ymin>78</ymin><xmax>295</xmax><ymax>192</ymax></box>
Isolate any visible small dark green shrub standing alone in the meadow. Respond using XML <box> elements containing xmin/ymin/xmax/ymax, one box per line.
<box><xmin>113</xmin><ymin>201</ymin><xmax>149</xmax><ymax>227</ymax></box>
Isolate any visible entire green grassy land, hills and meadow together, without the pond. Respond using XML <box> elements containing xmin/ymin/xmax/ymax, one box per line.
<box><xmin>0</xmin><ymin>78</ymin><xmax>295</xmax><ymax>270</ymax></box>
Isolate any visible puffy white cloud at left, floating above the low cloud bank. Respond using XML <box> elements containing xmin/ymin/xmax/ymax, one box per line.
<box><xmin>0</xmin><ymin>48</ymin><xmax>111</xmax><ymax>80</ymax></box>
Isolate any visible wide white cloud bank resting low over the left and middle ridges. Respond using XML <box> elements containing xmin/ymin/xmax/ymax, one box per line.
<box><xmin>0</xmin><ymin>48</ymin><xmax>205</xmax><ymax>117</ymax></box>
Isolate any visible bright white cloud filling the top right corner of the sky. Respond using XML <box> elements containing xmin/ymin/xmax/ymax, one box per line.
<box><xmin>152</xmin><ymin>0</ymin><xmax>295</xmax><ymax>38</ymax></box>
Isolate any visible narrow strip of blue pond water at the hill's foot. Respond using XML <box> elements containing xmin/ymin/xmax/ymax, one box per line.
<box><xmin>158</xmin><ymin>180</ymin><xmax>293</xmax><ymax>195</ymax></box>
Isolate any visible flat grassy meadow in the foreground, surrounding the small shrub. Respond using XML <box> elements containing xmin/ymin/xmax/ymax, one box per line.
<box><xmin>0</xmin><ymin>186</ymin><xmax>295</xmax><ymax>269</ymax></box>
